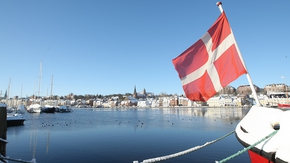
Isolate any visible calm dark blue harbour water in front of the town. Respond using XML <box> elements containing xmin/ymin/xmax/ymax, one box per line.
<box><xmin>6</xmin><ymin>108</ymin><xmax>249</xmax><ymax>163</ymax></box>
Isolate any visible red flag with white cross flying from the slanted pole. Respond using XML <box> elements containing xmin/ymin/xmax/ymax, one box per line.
<box><xmin>172</xmin><ymin>12</ymin><xmax>247</xmax><ymax>101</ymax></box>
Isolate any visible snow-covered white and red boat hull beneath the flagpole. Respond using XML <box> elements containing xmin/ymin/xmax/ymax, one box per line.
<box><xmin>236</xmin><ymin>106</ymin><xmax>290</xmax><ymax>163</ymax></box>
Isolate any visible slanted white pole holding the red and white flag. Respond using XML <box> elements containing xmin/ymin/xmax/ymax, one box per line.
<box><xmin>216</xmin><ymin>2</ymin><xmax>261</xmax><ymax>106</ymax></box>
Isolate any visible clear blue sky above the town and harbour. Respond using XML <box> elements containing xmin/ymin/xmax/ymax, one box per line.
<box><xmin>0</xmin><ymin>0</ymin><xmax>290</xmax><ymax>97</ymax></box>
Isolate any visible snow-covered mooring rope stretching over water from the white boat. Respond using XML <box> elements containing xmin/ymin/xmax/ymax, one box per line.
<box><xmin>133</xmin><ymin>131</ymin><xmax>235</xmax><ymax>163</ymax></box>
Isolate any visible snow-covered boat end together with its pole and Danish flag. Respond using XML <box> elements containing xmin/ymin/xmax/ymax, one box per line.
<box><xmin>172</xmin><ymin>2</ymin><xmax>290</xmax><ymax>163</ymax></box>
